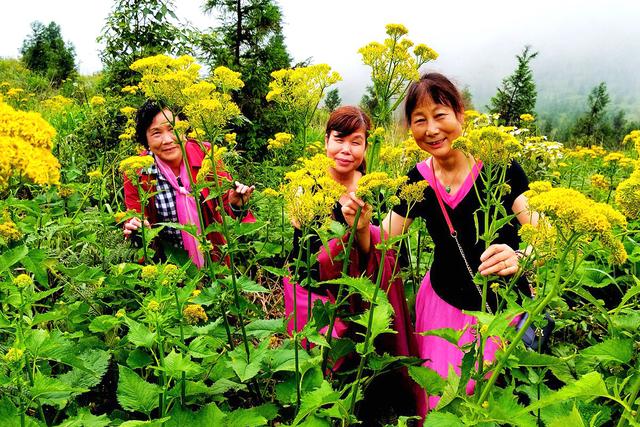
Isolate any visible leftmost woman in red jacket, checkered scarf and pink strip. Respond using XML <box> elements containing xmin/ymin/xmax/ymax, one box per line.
<box><xmin>124</xmin><ymin>100</ymin><xmax>255</xmax><ymax>267</ymax></box>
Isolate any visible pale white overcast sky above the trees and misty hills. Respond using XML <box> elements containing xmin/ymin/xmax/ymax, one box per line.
<box><xmin>0</xmin><ymin>0</ymin><xmax>640</xmax><ymax>108</ymax></box>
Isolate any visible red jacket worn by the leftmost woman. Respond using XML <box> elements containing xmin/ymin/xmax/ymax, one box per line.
<box><xmin>124</xmin><ymin>140</ymin><xmax>255</xmax><ymax>260</ymax></box>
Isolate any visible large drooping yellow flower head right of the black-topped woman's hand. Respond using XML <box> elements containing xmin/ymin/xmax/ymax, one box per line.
<box><xmin>525</xmin><ymin>182</ymin><xmax>627</xmax><ymax>263</ymax></box>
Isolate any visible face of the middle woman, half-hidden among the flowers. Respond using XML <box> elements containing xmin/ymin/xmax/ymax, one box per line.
<box><xmin>325</xmin><ymin>128</ymin><xmax>367</xmax><ymax>174</ymax></box>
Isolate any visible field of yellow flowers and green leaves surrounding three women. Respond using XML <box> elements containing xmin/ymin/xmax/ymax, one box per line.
<box><xmin>0</xmin><ymin>25</ymin><xmax>640</xmax><ymax>427</ymax></box>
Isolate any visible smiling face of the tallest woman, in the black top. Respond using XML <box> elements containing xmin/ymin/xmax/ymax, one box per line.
<box><xmin>410</xmin><ymin>97</ymin><xmax>464</xmax><ymax>158</ymax></box>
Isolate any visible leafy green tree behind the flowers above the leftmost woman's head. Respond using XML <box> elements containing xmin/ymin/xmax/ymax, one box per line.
<box><xmin>98</xmin><ymin>0</ymin><xmax>192</xmax><ymax>87</ymax></box>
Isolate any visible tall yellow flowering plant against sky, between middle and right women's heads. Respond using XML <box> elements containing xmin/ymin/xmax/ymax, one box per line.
<box><xmin>358</xmin><ymin>24</ymin><xmax>438</xmax><ymax>126</ymax></box>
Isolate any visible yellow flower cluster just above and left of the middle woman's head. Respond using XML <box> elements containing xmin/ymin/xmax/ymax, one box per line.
<box><xmin>267</xmin><ymin>64</ymin><xmax>342</xmax><ymax>115</ymax></box>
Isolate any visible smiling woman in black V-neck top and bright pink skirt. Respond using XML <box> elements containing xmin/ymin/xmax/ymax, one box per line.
<box><xmin>343</xmin><ymin>73</ymin><xmax>535</xmax><ymax>416</ymax></box>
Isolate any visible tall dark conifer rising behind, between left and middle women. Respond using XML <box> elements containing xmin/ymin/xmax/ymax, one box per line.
<box><xmin>200</xmin><ymin>0</ymin><xmax>291</xmax><ymax>155</ymax></box>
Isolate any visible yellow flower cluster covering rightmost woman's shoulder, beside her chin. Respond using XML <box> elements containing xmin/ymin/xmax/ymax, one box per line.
<box><xmin>452</xmin><ymin>126</ymin><xmax>522</xmax><ymax>166</ymax></box>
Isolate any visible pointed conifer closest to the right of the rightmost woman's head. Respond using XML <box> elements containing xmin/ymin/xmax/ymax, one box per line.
<box><xmin>489</xmin><ymin>46</ymin><xmax>538</xmax><ymax>126</ymax></box>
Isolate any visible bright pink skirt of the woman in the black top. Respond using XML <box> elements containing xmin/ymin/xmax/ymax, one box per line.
<box><xmin>416</xmin><ymin>272</ymin><xmax>510</xmax><ymax>419</ymax></box>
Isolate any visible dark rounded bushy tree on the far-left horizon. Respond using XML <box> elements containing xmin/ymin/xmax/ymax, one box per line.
<box><xmin>20</xmin><ymin>21</ymin><xmax>76</xmax><ymax>86</ymax></box>
